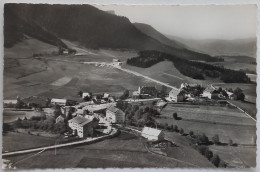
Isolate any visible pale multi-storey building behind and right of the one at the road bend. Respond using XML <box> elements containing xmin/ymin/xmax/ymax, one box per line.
<box><xmin>106</xmin><ymin>106</ymin><xmax>125</xmax><ymax>123</ymax></box>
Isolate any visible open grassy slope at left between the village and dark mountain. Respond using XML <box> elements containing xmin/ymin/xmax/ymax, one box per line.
<box><xmin>4</xmin><ymin>39</ymin><xmax>150</xmax><ymax>99</ymax></box>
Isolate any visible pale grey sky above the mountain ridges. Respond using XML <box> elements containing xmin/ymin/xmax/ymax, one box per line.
<box><xmin>95</xmin><ymin>5</ymin><xmax>257</xmax><ymax>40</ymax></box>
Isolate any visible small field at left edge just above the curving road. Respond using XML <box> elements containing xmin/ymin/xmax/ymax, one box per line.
<box><xmin>3</xmin><ymin>132</ymin><xmax>55</xmax><ymax>152</ymax></box>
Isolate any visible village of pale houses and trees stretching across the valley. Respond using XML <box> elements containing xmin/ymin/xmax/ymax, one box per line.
<box><xmin>4</xmin><ymin>83</ymin><xmax>244</xmax><ymax>140</ymax></box>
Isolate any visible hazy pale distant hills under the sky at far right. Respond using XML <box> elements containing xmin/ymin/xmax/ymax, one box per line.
<box><xmin>166</xmin><ymin>35</ymin><xmax>257</xmax><ymax>58</ymax></box>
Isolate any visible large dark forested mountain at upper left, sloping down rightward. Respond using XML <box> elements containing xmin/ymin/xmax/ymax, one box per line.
<box><xmin>4</xmin><ymin>4</ymin><xmax>219</xmax><ymax>61</ymax></box>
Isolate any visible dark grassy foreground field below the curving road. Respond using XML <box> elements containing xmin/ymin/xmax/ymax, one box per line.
<box><xmin>6</xmin><ymin>133</ymin><xmax>213</xmax><ymax>169</ymax></box>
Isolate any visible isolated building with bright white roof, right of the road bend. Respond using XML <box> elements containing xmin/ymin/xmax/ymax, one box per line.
<box><xmin>141</xmin><ymin>127</ymin><xmax>164</xmax><ymax>141</ymax></box>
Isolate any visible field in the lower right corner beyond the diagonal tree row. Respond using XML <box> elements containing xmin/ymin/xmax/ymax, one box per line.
<box><xmin>210</xmin><ymin>145</ymin><xmax>256</xmax><ymax>168</ymax></box>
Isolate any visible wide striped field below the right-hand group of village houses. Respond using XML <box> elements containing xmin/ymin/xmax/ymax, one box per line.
<box><xmin>157</xmin><ymin>104</ymin><xmax>256</xmax><ymax>144</ymax></box>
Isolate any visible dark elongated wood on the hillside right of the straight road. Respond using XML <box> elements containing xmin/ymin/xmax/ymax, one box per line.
<box><xmin>127</xmin><ymin>50</ymin><xmax>251</xmax><ymax>83</ymax></box>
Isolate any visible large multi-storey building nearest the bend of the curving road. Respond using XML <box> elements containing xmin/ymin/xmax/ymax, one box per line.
<box><xmin>68</xmin><ymin>116</ymin><xmax>98</xmax><ymax>138</ymax></box>
